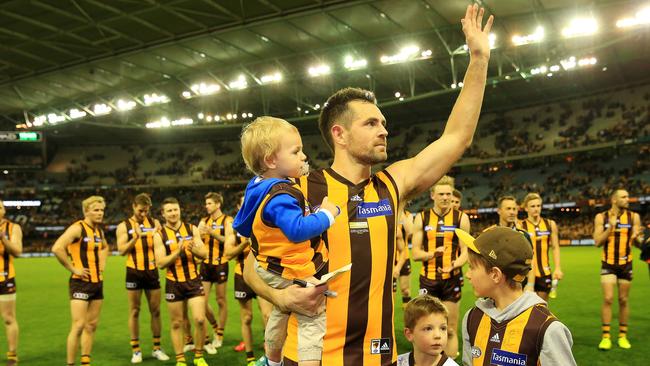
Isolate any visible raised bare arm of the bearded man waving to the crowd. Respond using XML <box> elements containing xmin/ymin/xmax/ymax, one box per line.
<box><xmin>387</xmin><ymin>5</ymin><xmax>494</xmax><ymax>198</ymax></box>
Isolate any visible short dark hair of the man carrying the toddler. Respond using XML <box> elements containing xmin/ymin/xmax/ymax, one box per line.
<box><xmin>318</xmin><ymin>88</ymin><xmax>377</xmax><ymax>151</ymax></box>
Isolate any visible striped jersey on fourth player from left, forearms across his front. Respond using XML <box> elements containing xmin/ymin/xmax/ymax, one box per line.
<box><xmin>160</xmin><ymin>222</ymin><xmax>199</xmax><ymax>282</ymax></box>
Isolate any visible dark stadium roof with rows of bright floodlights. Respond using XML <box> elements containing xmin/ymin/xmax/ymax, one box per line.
<box><xmin>0</xmin><ymin>0</ymin><xmax>650</xmax><ymax>139</ymax></box>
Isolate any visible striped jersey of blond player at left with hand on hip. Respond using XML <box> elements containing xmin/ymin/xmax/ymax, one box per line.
<box><xmin>67</xmin><ymin>220</ymin><xmax>105</xmax><ymax>283</ymax></box>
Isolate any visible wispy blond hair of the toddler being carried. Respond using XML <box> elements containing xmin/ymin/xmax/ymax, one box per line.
<box><xmin>241</xmin><ymin>116</ymin><xmax>298</xmax><ymax>175</ymax></box>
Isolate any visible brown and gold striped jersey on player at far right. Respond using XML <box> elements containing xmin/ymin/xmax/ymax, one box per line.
<box><xmin>601</xmin><ymin>210</ymin><xmax>634</xmax><ymax>265</ymax></box>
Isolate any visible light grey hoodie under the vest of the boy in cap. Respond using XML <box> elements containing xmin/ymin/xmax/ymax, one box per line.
<box><xmin>463</xmin><ymin>292</ymin><xmax>576</xmax><ymax>366</ymax></box>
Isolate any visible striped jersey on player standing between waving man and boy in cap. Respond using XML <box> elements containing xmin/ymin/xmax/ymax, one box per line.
<box><xmin>419</xmin><ymin>208</ymin><xmax>463</xmax><ymax>280</ymax></box>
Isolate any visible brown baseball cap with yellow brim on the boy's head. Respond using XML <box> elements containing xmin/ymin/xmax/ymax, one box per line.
<box><xmin>455</xmin><ymin>227</ymin><xmax>533</xmax><ymax>282</ymax></box>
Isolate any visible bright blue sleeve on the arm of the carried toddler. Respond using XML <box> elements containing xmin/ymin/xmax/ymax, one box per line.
<box><xmin>262</xmin><ymin>194</ymin><xmax>330</xmax><ymax>243</ymax></box>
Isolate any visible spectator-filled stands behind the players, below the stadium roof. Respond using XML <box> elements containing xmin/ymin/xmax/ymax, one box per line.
<box><xmin>0</xmin><ymin>86</ymin><xmax>650</xmax><ymax>252</ymax></box>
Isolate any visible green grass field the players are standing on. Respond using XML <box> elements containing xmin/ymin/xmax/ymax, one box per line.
<box><xmin>0</xmin><ymin>247</ymin><xmax>650</xmax><ymax>366</ymax></box>
